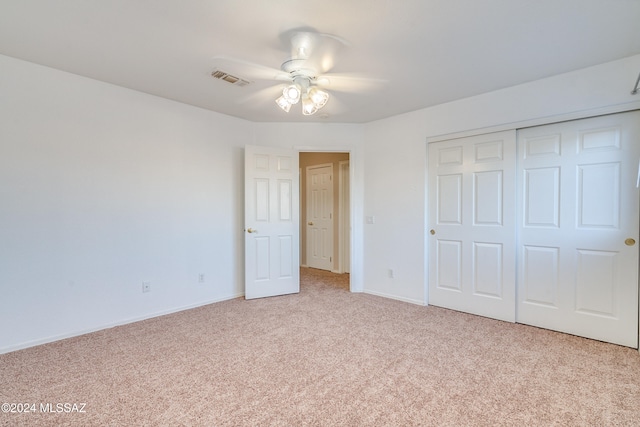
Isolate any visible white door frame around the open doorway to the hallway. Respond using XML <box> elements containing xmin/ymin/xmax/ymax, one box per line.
<box><xmin>293</xmin><ymin>145</ymin><xmax>364</xmax><ymax>292</ymax></box>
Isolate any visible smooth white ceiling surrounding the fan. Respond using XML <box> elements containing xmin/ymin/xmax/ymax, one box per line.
<box><xmin>0</xmin><ymin>0</ymin><xmax>640</xmax><ymax>123</ymax></box>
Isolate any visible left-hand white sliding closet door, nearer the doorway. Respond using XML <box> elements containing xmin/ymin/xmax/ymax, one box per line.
<box><xmin>428</xmin><ymin>131</ymin><xmax>516</xmax><ymax>322</ymax></box>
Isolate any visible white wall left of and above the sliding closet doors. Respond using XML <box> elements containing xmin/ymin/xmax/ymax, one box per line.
<box><xmin>364</xmin><ymin>55</ymin><xmax>640</xmax><ymax>303</ymax></box>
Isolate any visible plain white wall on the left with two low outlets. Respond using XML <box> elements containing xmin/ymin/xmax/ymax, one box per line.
<box><xmin>0</xmin><ymin>56</ymin><xmax>253</xmax><ymax>352</ymax></box>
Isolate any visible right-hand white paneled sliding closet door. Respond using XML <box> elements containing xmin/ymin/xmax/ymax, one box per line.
<box><xmin>518</xmin><ymin>112</ymin><xmax>640</xmax><ymax>347</ymax></box>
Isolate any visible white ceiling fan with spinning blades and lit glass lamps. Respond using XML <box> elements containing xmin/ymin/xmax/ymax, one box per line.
<box><xmin>212</xmin><ymin>28</ymin><xmax>382</xmax><ymax>116</ymax></box>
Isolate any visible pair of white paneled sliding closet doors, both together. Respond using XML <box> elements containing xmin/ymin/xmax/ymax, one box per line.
<box><xmin>428</xmin><ymin>111</ymin><xmax>640</xmax><ymax>348</ymax></box>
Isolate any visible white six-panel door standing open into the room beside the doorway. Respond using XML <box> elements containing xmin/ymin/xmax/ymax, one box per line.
<box><xmin>244</xmin><ymin>145</ymin><xmax>300</xmax><ymax>299</ymax></box>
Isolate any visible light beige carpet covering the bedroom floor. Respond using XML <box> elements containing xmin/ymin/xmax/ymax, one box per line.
<box><xmin>0</xmin><ymin>269</ymin><xmax>640</xmax><ymax>426</ymax></box>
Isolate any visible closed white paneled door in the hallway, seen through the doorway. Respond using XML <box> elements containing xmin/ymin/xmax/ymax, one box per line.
<box><xmin>307</xmin><ymin>164</ymin><xmax>333</xmax><ymax>271</ymax></box>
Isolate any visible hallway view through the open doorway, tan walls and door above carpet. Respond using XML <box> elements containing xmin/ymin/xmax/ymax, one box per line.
<box><xmin>299</xmin><ymin>152</ymin><xmax>351</xmax><ymax>274</ymax></box>
